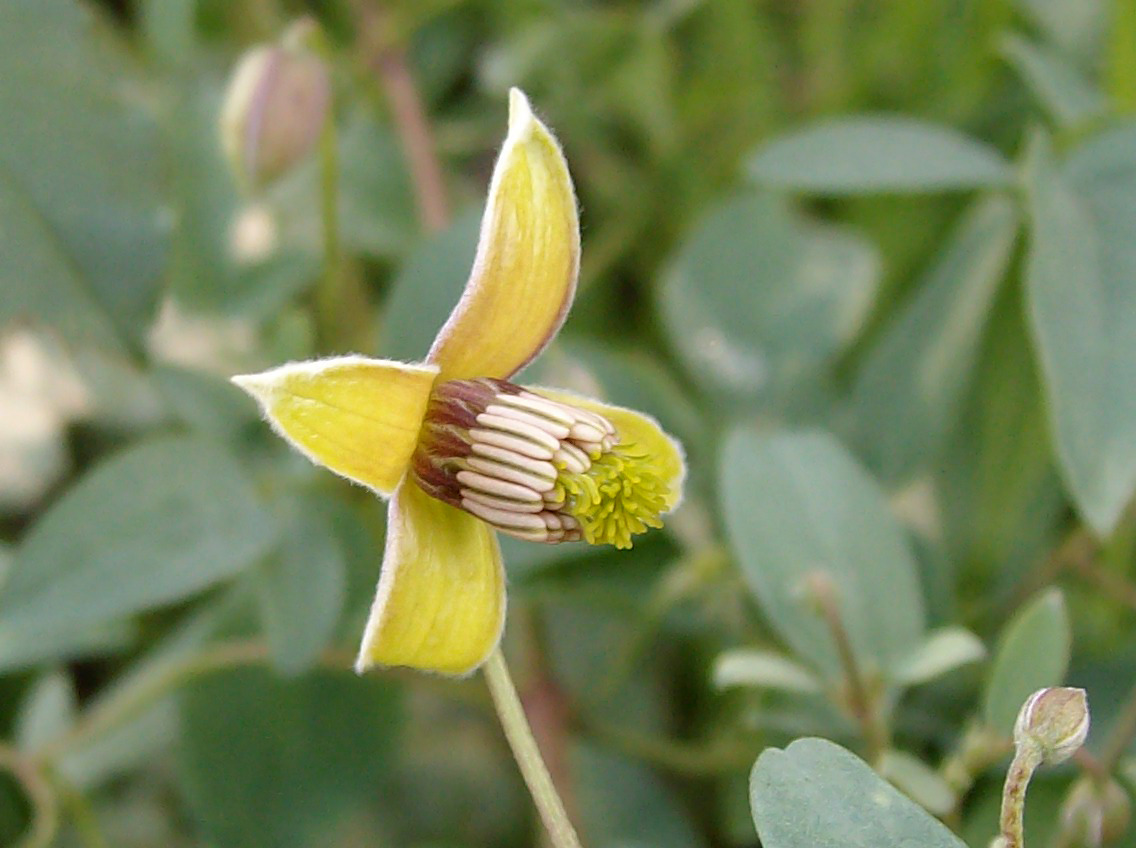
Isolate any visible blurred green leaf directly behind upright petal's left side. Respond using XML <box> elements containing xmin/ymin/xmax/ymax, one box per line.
<box><xmin>378</xmin><ymin>208</ymin><xmax>482</xmax><ymax>361</ymax></box>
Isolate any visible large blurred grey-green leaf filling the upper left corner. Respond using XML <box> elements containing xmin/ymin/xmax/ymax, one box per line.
<box><xmin>0</xmin><ymin>0</ymin><xmax>168</xmax><ymax>347</ymax></box>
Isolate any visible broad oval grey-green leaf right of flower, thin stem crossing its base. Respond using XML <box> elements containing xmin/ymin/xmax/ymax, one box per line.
<box><xmin>720</xmin><ymin>427</ymin><xmax>924</xmax><ymax>676</ymax></box>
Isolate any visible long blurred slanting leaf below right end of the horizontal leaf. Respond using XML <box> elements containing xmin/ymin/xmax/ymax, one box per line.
<box><xmin>852</xmin><ymin>196</ymin><xmax>1018</xmax><ymax>480</ymax></box>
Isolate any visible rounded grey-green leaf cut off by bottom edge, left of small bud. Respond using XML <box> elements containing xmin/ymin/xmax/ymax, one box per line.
<box><xmin>750</xmin><ymin>739</ymin><xmax>963</xmax><ymax>848</ymax></box>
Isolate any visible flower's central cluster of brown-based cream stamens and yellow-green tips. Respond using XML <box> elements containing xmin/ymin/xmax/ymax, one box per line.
<box><xmin>411</xmin><ymin>379</ymin><xmax>670</xmax><ymax>548</ymax></box>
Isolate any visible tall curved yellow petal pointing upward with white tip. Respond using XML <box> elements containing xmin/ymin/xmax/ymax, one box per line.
<box><xmin>427</xmin><ymin>89</ymin><xmax>579</xmax><ymax>380</ymax></box>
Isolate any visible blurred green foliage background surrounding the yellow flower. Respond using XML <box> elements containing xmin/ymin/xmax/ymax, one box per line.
<box><xmin>0</xmin><ymin>0</ymin><xmax>1136</xmax><ymax>848</ymax></box>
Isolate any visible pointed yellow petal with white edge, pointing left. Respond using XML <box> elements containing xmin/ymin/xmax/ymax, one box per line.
<box><xmin>233</xmin><ymin>356</ymin><xmax>437</xmax><ymax>496</ymax></box>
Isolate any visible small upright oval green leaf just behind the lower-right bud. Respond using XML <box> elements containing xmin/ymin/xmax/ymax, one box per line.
<box><xmin>983</xmin><ymin>589</ymin><xmax>1072</xmax><ymax>737</ymax></box>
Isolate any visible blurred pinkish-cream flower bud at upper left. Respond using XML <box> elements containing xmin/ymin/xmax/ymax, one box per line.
<box><xmin>220</xmin><ymin>21</ymin><xmax>332</xmax><ymax>188</ymax></box>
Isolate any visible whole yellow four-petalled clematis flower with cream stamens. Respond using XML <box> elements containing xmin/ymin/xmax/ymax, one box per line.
<box><xmin>233</xmin><ymin>89</ymin><xmax>685</xmax><ymax>674</ymax></box>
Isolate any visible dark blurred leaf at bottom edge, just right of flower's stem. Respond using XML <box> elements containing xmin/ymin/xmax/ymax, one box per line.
<box><xmin>569</xmin><ymin>742</ymin><xmax>705</xmax><ymax>848</ymax></box>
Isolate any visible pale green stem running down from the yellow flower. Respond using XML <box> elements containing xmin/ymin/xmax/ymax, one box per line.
<box><xmin>485</xmin><ymin>648</ymin><xmax>580</xmax><ymax>848</ymax></box>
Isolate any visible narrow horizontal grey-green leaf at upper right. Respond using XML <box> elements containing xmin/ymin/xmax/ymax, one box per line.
<box><xmin>750</xmin><ymin>115</ymin><xmax>1011</xmax><ymax>196</ymax></box>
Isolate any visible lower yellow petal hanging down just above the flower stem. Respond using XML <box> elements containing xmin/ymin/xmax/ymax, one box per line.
<box><xmin>356</xmin><ymin>479</ymin><xmax>504</xmax><ymax>674</ymax></box>
